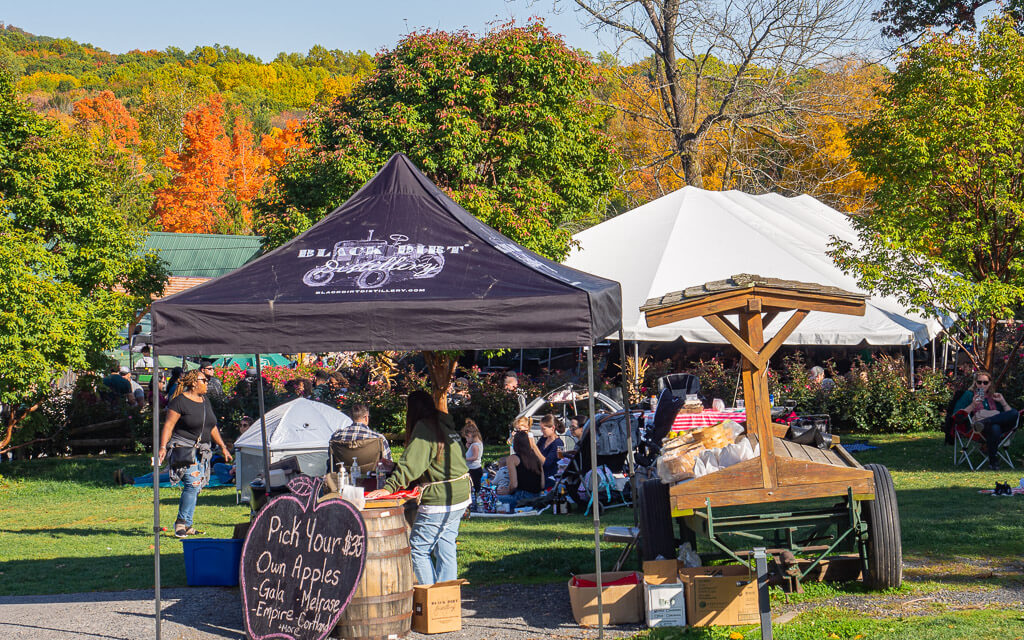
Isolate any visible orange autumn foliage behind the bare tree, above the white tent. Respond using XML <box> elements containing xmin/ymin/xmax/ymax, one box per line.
<box><xmin>601</xmin><ymin>59</ymin><xmax>886</xmax><ymax>213</ymax></box>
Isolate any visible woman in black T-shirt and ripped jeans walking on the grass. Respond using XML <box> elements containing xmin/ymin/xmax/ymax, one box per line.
<box><xmin>159</xmin><ymin>370</ymin><xmax>231</xmax><ymax>538</ymax></box>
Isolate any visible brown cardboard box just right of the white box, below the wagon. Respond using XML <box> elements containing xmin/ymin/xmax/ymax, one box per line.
<box><xmin>679</xmin><ymin>564</ymin><xmax>761</xmax><ymax>627</ymax></box>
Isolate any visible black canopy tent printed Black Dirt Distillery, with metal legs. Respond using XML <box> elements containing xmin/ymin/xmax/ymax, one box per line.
<box><xmin>144</xmin><ymin>154</ymin><xmax>628</xmax><ymax>638</ymax></box>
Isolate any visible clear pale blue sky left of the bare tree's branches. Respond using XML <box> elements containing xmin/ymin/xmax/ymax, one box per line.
<box><xmin>0</xmin><ymin>0</ymin><xmax>614</xmax><ymax>60</ymax></box>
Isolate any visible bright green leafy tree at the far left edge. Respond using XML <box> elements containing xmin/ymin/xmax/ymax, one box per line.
<box><xmin>0</xmin><ymin>72</ymin><xmax>166</xmax><ymax>452</ymax></box>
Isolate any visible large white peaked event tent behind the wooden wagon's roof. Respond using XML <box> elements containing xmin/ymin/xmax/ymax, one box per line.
<box><xmin>565</xmin><ymin>186</ymin><xmax>942</xmax><ymax>345</ymax></box>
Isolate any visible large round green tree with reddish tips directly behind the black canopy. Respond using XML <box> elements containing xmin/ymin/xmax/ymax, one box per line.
<box><xmin>257</xmin><ymin>24</ymin><xmax>612</xmax><ymax>259</ymax></box>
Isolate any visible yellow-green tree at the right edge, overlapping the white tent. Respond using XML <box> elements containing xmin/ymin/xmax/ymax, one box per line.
<box><xmin>833</xmin><ymin>16</ymin><xmax>1024</xmax><ymax>369</ymax></box>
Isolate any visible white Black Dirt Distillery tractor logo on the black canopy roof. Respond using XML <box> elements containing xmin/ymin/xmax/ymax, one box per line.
<box><xmin>299</xmin><ymin>229</ymin><xmax>452</xmax><ymax>289</ymax></box>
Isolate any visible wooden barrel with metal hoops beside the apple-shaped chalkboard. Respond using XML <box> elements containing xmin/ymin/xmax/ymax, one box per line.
<box><xmin>334</xmin><ymin>507</ymin><xmax>415</xmax><ymax>640</ymax></box>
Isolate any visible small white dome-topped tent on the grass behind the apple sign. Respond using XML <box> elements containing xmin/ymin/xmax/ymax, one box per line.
<box><xmin>234</xmin><ymin>397</ymin><xmax>352</xmax><ymax>500</ymax></box>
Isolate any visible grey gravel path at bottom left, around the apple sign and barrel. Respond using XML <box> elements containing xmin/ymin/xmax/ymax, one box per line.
<box><xmin>0</xmin><ymin>584</ymin><xmax>639</xmax><ymax>640</ymax></box>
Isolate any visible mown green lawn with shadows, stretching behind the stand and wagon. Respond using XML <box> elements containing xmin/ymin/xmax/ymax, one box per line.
<box><xmin>0</xmin><ymin>433</ymin><xmax>1024</xmax><ymax>598</ymax></box>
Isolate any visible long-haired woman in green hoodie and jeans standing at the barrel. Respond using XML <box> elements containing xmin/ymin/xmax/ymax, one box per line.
<box><xmin>367</xmin><ymin>390</ymin><xmax>472</xmax><ymax>585</ymax></box>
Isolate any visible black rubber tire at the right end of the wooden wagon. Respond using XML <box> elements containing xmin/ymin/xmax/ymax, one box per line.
<box><xmin>862</xmin><ymin>464</ymin><xmax>903</xmax><ymax>589</ymax></box>
